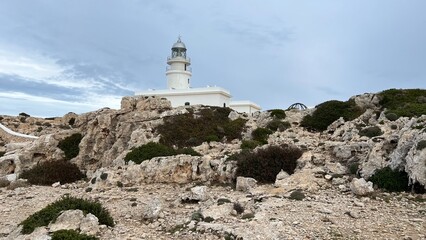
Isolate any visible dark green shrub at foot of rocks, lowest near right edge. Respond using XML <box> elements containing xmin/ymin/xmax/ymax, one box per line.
<box><xmin>368</xmin><ymin>167</ymin><xmax>409</xmax><ymax>192</ymax></box>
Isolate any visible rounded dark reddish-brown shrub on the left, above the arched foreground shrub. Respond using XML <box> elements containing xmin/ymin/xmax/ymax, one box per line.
<box><xmin>20</xmin><ymin>160</ymin><xmax>84</xmax><ymax>185</ymax></box>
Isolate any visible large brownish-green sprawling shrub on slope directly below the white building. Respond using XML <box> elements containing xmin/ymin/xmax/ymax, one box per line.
<box><xmin>158</xmin><ymin>107</ymin><xmax>246</xmax><ymax>147</ymax></box>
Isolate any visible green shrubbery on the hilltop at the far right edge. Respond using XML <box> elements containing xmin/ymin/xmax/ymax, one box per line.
<box><xmin>379</xmin><ymin>89</ymin><xmax>426</xmax><ymax>117</ymax></box>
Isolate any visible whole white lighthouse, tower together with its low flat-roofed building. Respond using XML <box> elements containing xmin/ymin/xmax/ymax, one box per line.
<box><xmin>135</xmin><ymin>37</ymin><xmax>261</xmax><ymax>113</ymax></box>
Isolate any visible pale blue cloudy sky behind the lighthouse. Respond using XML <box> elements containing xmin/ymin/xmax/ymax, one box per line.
<box><xmin>0</xmin><ymin>0</ymin><xmax>426</xmax><ymax>117</ymax></box>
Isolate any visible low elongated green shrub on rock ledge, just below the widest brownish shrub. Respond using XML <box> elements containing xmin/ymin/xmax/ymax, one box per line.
<box><xmin>124</xmin><ymin>142</ymin><xmax>201</xmax><ymax>164</ymax></box>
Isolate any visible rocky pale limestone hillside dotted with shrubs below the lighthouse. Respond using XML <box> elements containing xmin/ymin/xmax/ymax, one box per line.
<box><xmin>0</xmin><ymin>90</ymin><xmax>426</xmax><ymax>239</ymax></box>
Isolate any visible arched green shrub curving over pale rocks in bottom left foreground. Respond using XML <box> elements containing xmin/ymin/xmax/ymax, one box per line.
<box><xmin>19</xmin><ymin>196</ymin><xmax>114</xmax><ymax>234</ymax></box>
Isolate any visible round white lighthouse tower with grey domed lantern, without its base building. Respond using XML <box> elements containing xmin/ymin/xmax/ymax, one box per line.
<box><xmin>166</xmin><ymin>36</ymin><xmax>192</xmax><ymax>89</ymax></box>
